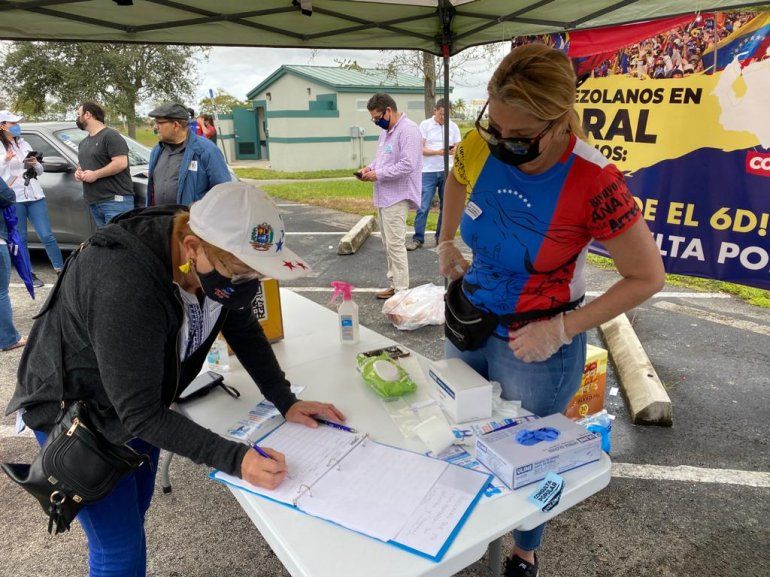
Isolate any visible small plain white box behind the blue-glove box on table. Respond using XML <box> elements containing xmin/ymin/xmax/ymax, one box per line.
<box><xmin>428</xmin><ymin>359</ymin><xmax>492</xmax><ymax>423</ymax></box>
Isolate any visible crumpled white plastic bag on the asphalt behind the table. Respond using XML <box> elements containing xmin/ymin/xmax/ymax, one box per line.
<box><xmin>382</xmin><ymin>284</ymin><xmax>444</xmax><ymax>331</ymax></box>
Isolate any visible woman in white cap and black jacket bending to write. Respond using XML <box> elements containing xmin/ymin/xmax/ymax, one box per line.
<box><xmin>7</xmin><ymin>182</ymin><xmax>344</xmax><ymax>577</ymax></box>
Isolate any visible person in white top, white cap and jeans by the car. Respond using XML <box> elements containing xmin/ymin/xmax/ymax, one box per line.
<box><xmin>0</xmin><ymin>110</ymin><xmax>64</xmax><ymax>288</ymax></box>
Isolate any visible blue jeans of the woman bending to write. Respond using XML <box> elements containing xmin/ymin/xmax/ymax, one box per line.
<box><xmin>35</xmin><ymin>431</ymin><xmax>160</xmax><ymax>577</ymax></box>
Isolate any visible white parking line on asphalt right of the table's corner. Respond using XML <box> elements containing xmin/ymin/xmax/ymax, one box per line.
<box><xmin>612</xmin><ymin>463</ymin><xmax>770</xmax><ymax>487</ymax></box>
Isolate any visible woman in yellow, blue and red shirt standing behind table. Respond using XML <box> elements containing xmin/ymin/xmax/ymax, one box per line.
<box><xmin>438</xmin><ymin>44</ymin><xmax>664</xmax><ymax>577</ymax></box>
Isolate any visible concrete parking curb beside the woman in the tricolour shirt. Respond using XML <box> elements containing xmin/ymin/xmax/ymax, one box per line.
<box><xmin>599</xmin><ymin>314</ymin><xmax>673</xmax><ymax>427</ymax></box>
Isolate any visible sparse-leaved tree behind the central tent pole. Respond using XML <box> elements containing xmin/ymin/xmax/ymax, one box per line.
<box><xmin>378</xmin><ymin>43</ymin><xmax>500</xmax><ymax>118</ymax></box>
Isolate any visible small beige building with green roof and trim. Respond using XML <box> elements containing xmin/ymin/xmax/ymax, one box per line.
<box><xmin>232</xmin><ymin>65</ymin><xmax>443</xmax><ymax>171</ymax></box>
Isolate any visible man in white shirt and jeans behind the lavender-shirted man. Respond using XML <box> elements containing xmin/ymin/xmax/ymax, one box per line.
<box><xmin>406</xmin><ymin>98</ymin><xmax>460</xmax><ymax>250</ymax></box>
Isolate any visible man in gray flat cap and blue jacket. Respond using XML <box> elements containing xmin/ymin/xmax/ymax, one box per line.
<box><xmin>147</xmin><ymin>102</ymin><xmax>232</xmax><ymax>206</ymax></box>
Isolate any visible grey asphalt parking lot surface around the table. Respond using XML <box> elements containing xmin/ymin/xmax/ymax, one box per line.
<box><xmin>0</xmin><ymin>203</ymin><xmax>770</xmax><ymax>577</ymax></box>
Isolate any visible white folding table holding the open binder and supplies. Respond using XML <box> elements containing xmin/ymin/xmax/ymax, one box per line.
<box><xmin>177</xmin><ymin>289</ymin><xmax>610</xmax><ymax>577</ymax></box>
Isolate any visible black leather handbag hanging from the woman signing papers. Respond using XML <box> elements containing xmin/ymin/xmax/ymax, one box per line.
<box><xmin>0</xmin><ymin>401</ymin><xmax>152</xmax><ymax>534</ymax></box>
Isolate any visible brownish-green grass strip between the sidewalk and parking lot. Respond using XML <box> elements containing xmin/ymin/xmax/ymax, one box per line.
<box><xmin>260</xmin><ymin>182</ymin><xmax>438</xmax><ymax>230</ymax></box>
